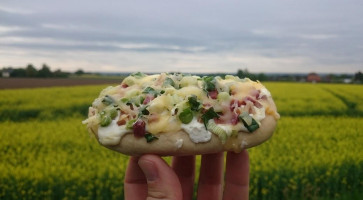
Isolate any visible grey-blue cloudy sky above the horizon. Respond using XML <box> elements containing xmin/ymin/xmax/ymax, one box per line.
<box><xmin>0</xmin><ymin>0</ymin><xmax>363</xmax><ymax>73</ymax></box>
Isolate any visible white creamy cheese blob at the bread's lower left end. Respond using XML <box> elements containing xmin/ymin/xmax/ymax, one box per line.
<box><xmin>98</xmin><ymin>114</ymin><xmax>131</xmax><ymax>145</ymax></box>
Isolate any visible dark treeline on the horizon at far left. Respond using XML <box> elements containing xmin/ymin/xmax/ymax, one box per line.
<box><xmin>1</xmin><ymin>64</ymin><xmax>83</xmax><ymax>78</ymax></box>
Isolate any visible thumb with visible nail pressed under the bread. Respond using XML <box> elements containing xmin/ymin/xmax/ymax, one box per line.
<box><xmin>138</xmin><ymin>155</ymin><xmax>182</xmax><ymax>200</ymax></box>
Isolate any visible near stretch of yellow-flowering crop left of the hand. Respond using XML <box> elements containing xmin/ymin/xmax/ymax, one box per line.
<box><xmin>0</xmin><ymin>118</ymin><xmax>127</xmax><ymax>199</ymax></box>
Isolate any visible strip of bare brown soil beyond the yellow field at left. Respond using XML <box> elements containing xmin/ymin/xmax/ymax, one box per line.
<box><xmin>0</xmin><ymin>78</ymin><xmax>122</xmax><ymax>89</ymax></box>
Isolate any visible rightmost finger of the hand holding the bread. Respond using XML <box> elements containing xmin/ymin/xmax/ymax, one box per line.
<box><xmin>223</xmin><ymin>150</ymin><xmax>249</xmax><ymax>199</ymax></box>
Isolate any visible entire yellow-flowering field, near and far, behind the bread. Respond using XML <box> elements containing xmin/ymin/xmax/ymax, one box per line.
<box><xmin>0</xmin><ymin>83</ymin><xmax>363</xmax><ymax>199</ymax></box>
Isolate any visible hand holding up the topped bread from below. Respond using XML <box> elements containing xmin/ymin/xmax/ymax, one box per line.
<box><xmin>124</xmin><ymin>150</ymin><xmax>249</xmax><ymax>200</ymax></box>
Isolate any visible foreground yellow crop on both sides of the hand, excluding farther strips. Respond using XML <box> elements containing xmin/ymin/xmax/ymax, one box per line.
<box><xmin>0</xmin><ymin>117</ymin><xmax>363</xmax><ymax>199</ymax></box>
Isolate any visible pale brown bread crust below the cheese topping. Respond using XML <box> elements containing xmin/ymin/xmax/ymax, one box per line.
<box><xmin>92</xmin><ymin>110</ymin><xmax>277</xmax><ymax>156</ymax></box>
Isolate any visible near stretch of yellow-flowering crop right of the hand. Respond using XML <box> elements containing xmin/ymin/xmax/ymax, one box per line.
<box><xmin>250</xmin><ymin>117</ymin><xmax>363</xmax><ymax>199</ymax></box>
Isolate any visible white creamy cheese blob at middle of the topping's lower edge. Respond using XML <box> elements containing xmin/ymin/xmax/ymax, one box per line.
<box><xmin>181</xmin><ymin>118</ymin><xmax>212</xmax><ymax>143</ymax></box>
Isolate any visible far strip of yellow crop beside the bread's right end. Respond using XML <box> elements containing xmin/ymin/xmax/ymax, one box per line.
<box><xmin>265</xmin><ymin>83</ymin><xmax>363</xmax><ymax>116</ymax></box>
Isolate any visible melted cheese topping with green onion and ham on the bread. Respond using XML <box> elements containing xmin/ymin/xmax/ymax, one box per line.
<box><xmin>84</xmin><ymin>73</ymin><xmax>279</xmax><ymax>146</ymax></box>
